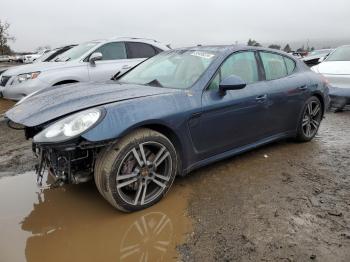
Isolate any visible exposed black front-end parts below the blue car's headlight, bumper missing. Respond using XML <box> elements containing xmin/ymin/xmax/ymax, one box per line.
<box><xmin>33</xmin><ymin>143</ymin><xmax>110</xmax><ymax>187</ymax></box>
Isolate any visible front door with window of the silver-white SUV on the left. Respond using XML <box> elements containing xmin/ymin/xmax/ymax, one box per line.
<box><xmin>87</xmin><ymin>42</ymin><xmax>130</xmax><ymax>82</ymax></box>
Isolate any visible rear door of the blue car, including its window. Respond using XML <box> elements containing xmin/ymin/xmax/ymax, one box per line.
<box><xmin>259</xmin><ymin>51</ymin><xmax>308</xmax><ymax>136</ymax></box>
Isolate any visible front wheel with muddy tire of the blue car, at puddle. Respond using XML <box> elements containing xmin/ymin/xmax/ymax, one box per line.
<box><xmin>94</xmin><ymin>128</ymin><xmax>178</xmax><ymax>212</ymax></box>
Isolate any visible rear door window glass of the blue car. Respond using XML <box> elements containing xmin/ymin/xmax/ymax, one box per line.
<box><xmin>260</xmin><ymin>52</ymin><xmax>288</xmax><ymax>80</ymax></box>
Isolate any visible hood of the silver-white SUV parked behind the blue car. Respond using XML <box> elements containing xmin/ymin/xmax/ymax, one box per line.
<box><xmin>4</xmin><ymin>62</ymin><xmax>72</xmax><ymax>76</ymax></box>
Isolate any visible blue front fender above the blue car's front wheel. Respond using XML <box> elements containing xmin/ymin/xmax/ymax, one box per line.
<box><xmin>82</xmin><ymin>91</ymin><xmax>194</xmax><ymax>142</ymax></box>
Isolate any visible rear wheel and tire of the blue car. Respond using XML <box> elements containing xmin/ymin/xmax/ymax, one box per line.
<box><xmin>296</xmin><ymin>96</ymin><xmax>323</xmax><ymax>142</ymax></box>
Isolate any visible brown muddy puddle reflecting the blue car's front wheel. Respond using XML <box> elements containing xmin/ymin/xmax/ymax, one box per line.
<box><xmin>0</xmin><ymin>172</ymin><xmax>191</xmax><ymax>261</ymax></box>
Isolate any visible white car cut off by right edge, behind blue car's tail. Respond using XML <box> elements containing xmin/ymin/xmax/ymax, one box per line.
<box><xmin>312</xmin><ymin>45</ymin><xmax>350</xmax><ymax>110</ymax></box>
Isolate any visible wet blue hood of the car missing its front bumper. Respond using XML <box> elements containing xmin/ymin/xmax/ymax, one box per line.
<box><xmin>6</xmin><ymin>81</ymin><xmax>178</xmax><ymax>127</ymax></box>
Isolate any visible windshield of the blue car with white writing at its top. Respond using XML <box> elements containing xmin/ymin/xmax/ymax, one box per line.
<box><xmin>118</xmin><ymin>50</ymin><xmax>216</xmax><ymax>89</ymax></box>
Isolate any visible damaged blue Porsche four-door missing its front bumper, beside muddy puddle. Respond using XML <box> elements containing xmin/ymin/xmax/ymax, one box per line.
<box><xmin>6</xmin><ymin>46</ymin><xmax>329</xmax><ymax>212</ymax></box>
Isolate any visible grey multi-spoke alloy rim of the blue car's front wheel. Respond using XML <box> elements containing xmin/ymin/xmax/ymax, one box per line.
<box><xmin>116</xmin><ymin>141</ymin><xmax>172</xmax><ymax>206</ymax></box>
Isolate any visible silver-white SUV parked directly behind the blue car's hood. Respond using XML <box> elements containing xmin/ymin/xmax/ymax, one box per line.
<box><xmin>0</xmin><ymin>37</ymin><xmax>169</xmax><ymax>100</ymax></box>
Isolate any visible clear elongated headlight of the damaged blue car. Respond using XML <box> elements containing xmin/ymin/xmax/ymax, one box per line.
<box><xmin>34</xmin><ymin>108</ymin><xmax>103</xmax><ymax>143</ymax></box>
